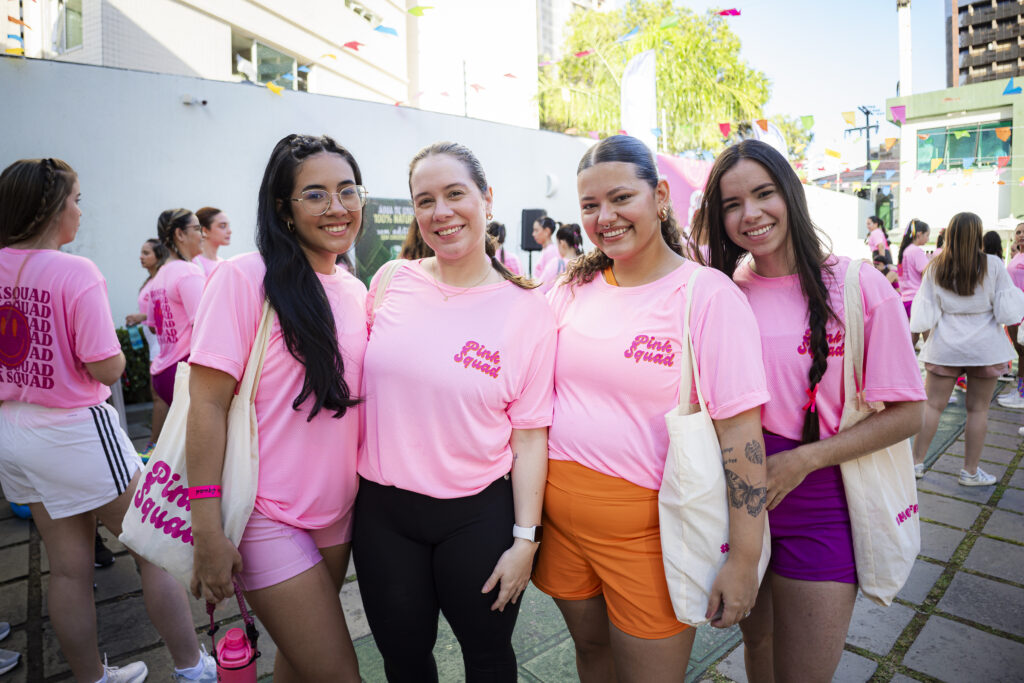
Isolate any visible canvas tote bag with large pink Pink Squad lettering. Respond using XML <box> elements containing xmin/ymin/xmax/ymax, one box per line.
<box><xmin>119</xmin><ymin>302</ymin><xmax>274</xmax><ymax>590</ymax></box>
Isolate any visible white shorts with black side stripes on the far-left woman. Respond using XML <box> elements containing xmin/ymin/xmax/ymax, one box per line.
<box><xmin>0</xmin><ymin>400</ymin><xmax>142</xmax><ymax>519</ymax></box>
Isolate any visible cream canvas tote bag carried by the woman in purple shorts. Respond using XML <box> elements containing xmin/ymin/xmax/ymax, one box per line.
<box><xmin>839</xmin><ymin>260</ymin><xmax>921</xmax><ymax>606</ymax></box>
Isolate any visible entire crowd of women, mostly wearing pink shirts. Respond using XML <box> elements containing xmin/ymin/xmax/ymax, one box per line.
<box><xmin>0</xmin><ymin>134</ymin><xmax>1024</xmax><ymax>683</ymax></box>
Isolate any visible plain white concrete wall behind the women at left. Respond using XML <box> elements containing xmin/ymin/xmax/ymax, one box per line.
<box><xmin>0</xmin><ymin>56</ymin><xmax>591</xmax><ymax>321</ymax></box>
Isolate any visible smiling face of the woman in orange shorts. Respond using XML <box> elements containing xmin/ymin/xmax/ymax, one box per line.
<box><xmin>577</xmin><ymin>162</ymin><xmax>669</xmax><ymax>261</ymax></box>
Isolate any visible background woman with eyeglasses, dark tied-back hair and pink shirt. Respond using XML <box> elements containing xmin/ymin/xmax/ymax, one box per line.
<box><xmin>142</xmin><ymin>209</ymin><xmax>205</xmax><ymax>405</ymax></box>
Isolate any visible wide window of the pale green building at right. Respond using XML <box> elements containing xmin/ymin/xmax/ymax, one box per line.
<box><xmin>918</xmin><ymin>121</ymin><xmax>1014</xmax><ymax>172</ymax></box>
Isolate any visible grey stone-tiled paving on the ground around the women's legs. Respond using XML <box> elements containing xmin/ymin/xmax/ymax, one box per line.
<box><xmin>0</xmin><ymin>394</ymin><xmax>1024</xmax><ymax>683</ymax></box>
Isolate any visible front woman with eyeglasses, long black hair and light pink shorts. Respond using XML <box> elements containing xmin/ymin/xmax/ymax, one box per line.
<box><xmin>188</xmin><ymin>135</ymin><xmax>367</xmax><ymax>681</ymax></box>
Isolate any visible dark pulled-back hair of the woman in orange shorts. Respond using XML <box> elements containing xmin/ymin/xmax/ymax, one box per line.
<box><xmin>565</xmin><ymin>135</ymin><xmax>684</xmax><ymax>287</ymax></box>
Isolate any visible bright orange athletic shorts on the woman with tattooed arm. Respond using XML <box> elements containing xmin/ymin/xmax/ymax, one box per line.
<box><xmin>534</xmin><ymin>460</ymin><xmax>689</xmax><ymax>640</ymax></box>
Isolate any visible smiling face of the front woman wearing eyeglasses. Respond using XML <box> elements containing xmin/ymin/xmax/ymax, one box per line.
<box><xmin>282</xmin><ymin>152</ymin><xmax>362</xmax><ymax>274</ymax></box>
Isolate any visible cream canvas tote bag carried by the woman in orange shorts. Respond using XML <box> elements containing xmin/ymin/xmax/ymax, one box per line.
<box><xmin>657</xmin><ymin>267</ymin><xmax>771</xmax><ymax>626</ymax></box>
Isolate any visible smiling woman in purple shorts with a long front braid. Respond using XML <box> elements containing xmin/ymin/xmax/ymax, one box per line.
<box><xmin>693</xmin><ymin>140</ymin><xmax>925</xmax><ymax>682</ymax></box>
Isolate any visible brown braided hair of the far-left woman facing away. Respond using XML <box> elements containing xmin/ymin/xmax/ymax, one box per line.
<box><xmin>0</xmin><ymin>159</ymin><xmax>78</xmax><ymax>247</ymax></box>
